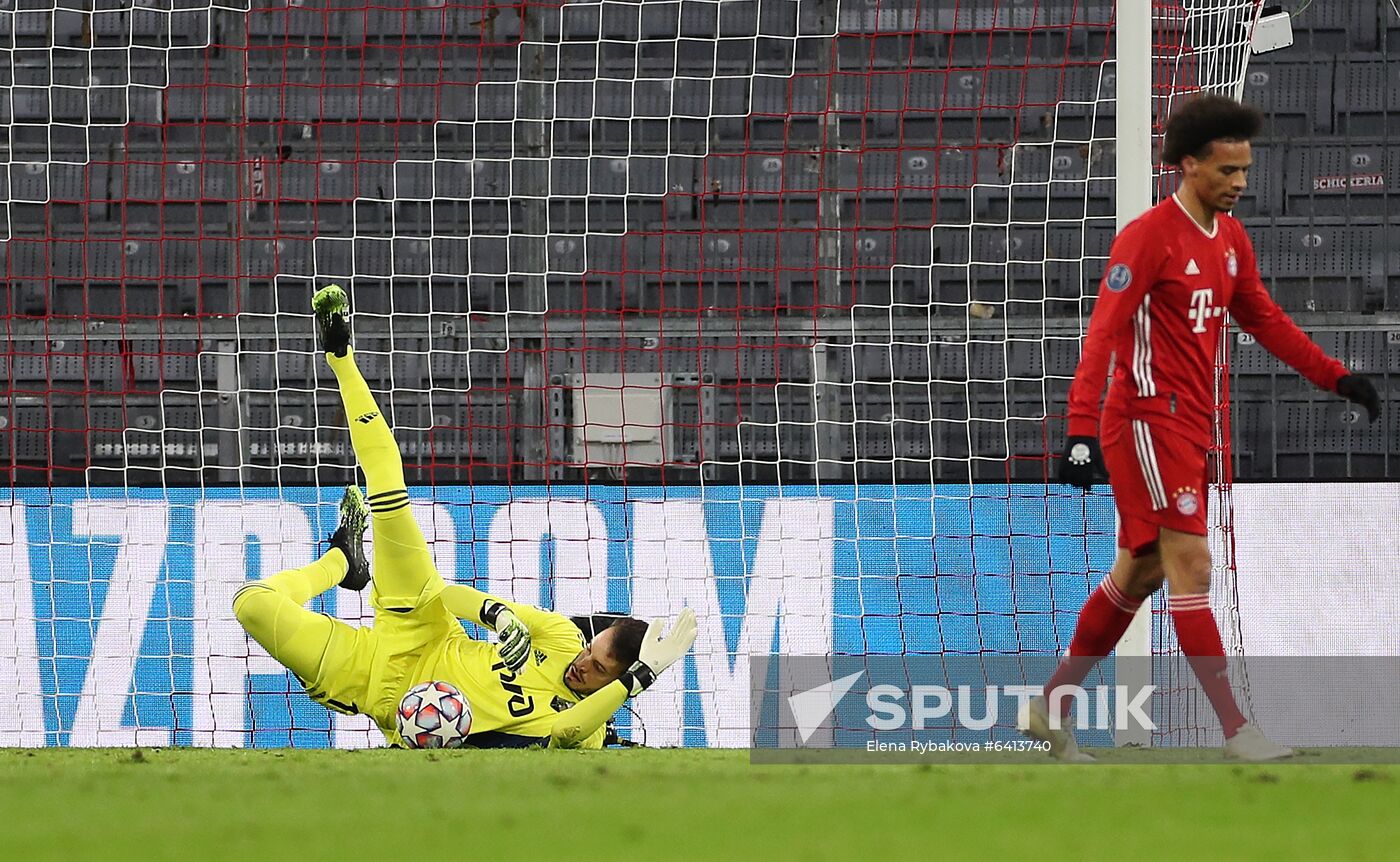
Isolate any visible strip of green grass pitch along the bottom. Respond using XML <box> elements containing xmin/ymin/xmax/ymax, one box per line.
<box><xmin>0</xmin><ymin>749</ymin><xmax>1400</xmax><ymax>862</ymax></box>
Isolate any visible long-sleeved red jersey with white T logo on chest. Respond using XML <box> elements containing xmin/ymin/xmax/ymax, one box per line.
<box><xmin>1070</xmin><ymin>195</ymin><xmax>1348</xmax><ymax>446</ymax></box>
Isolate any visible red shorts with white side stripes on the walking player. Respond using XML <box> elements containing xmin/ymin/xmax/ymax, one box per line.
<box><xmin>1100</xmin><ymin>420</ymin><xmax>1208</xmax><ymax>557</ymax></box>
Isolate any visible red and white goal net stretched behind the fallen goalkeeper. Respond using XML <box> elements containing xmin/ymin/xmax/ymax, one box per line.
<box><xmin>0</xmin><ymin>0</ymin><xmax>1257</xmax><ymax>746</ymax></box>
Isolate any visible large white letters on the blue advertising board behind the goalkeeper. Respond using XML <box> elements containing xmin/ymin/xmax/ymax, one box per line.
<box><xmin>0</xmin><ymin>498</ymin><xmax>834</xmax><ymax>747</ymax></box>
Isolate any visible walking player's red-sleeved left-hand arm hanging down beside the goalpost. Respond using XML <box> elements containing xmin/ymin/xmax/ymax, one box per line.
<box><xmin>1060</xmin><ymin>220</ymin><xmax>1166</xmax><ymax>491</ymax></box>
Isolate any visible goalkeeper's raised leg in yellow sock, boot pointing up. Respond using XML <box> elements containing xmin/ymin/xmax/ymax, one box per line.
<box><xmin>312</xmin><ymin>284</ymin><xmax>445</xmax><ymax>613</ymax></box>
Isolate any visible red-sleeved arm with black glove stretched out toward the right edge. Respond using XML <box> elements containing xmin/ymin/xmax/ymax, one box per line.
<box><xmin>1229</xmin><ymin>229</ymin><xmax>1380</xmax><ymax>421</ymax></box>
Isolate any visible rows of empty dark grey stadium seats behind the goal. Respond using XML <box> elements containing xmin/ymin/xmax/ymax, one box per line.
<box><xmin>0</xmin><ymin>0</ymin><xmax>1400</xmax><ymax>483</ymax></box>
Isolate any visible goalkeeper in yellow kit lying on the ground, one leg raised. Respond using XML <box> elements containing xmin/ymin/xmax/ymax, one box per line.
<box><xmin>234</xmin><ymin>284</ymin><xmax>696</xmax><ymax>749</ymax></box>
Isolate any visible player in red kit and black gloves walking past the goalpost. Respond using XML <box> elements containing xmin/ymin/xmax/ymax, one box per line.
<box><xmin>1022</xmin><ymin>95</ymin><xmax>1380</xmax><ymax>760</ymax></box>
